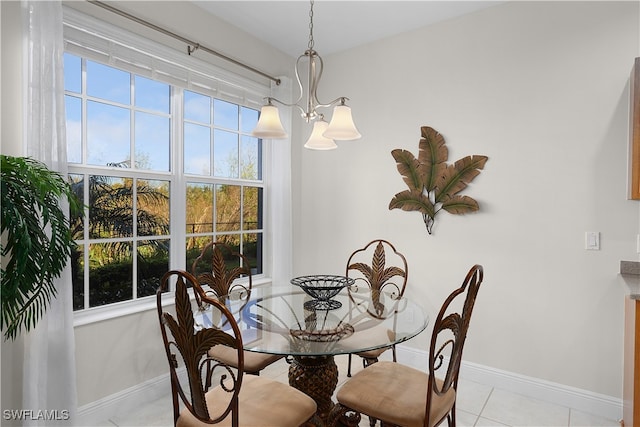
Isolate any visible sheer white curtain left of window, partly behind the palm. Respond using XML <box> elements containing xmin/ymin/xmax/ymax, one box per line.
<box><xmin>22</xmin><ymin>0</ymin><xmax>77</xmax><ymax>426</ymax></box>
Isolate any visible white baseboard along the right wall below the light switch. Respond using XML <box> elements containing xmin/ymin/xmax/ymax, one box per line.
<box><xmin>397</xmin><ymin>345</ymin><xmax>622</xmax><ymax>420</ymax></box>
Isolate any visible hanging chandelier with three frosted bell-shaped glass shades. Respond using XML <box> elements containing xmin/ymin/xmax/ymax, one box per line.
<box><xmin>253</xmin><ymin>0</ymin><xmax>362</xmax><ymax>150</ymax></box>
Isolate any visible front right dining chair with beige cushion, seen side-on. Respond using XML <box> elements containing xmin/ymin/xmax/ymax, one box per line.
<box><xmin>329</xmin><ymin>265</ymin><xmax>484</xmax><ymax>427</ymax></box>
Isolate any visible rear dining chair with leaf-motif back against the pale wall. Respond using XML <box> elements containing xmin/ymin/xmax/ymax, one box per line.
<box><xmin>345</xmin><ymin>239</ymin><xmax>409</xmax><ymax>377</ymax></box>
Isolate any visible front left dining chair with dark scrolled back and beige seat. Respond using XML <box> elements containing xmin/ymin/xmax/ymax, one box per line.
<box><xmin>156</xmin><ymin>270</ymin><xmax>317</xmax><ymax>427</ymax></box>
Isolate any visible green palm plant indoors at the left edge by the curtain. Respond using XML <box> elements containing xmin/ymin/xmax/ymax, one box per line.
<box><xmin>0</xmin><ymin>155</ymin><xmax>82</xmax><ymax>340</ymax></box>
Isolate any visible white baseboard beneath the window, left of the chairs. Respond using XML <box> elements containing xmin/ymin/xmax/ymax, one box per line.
<box><xmin>75</xmin><ymin>374</ymin><xmax>171</xmax><ymax>427</ymax></box>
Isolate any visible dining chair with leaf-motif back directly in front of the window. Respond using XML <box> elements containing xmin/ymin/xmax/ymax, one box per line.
<box><xmin>191</xmin><ymin>242</ymin><xmax>284</xmax><ymax>375</ymax></box>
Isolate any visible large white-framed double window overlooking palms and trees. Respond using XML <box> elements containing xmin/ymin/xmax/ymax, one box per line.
<box><xmin>64</xmin><ymin>11</ymin><xmax>266</xmax><ymax>311</ymax></box>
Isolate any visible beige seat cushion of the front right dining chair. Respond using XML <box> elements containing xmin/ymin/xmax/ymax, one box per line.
<box><xmin>337</xmin><ymin>361</ymin><xmax>456</xmax><ymax>427</ymax></box>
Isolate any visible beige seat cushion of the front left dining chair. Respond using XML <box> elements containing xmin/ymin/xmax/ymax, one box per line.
<box><xmin>176</xmin><ymin>375</ymin><xmax>317</xmax><ymax>427</ymax></box>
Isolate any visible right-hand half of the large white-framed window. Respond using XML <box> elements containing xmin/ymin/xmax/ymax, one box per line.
<box><xmin>182</xmin><ymin>90</ymin><xmax>264</xmax><ymax>275</ymax></box>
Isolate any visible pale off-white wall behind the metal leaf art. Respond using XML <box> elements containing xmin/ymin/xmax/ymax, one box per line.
<box><xmin>294</xmin><ymin>2</ymin><xmax>640</xmax><ymax>397</ymax></box>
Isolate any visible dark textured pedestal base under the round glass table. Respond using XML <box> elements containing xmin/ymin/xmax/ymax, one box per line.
<box><xmin>289</xmin><ymin>356</ymin><xmax>338</xmax><ymax>423</ymax></box>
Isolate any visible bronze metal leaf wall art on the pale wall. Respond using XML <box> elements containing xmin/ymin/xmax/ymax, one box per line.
<box><xmin>389</xmin><ymin>126</ymin><xmax>489</xmax><ymax>234</ymax></box>
